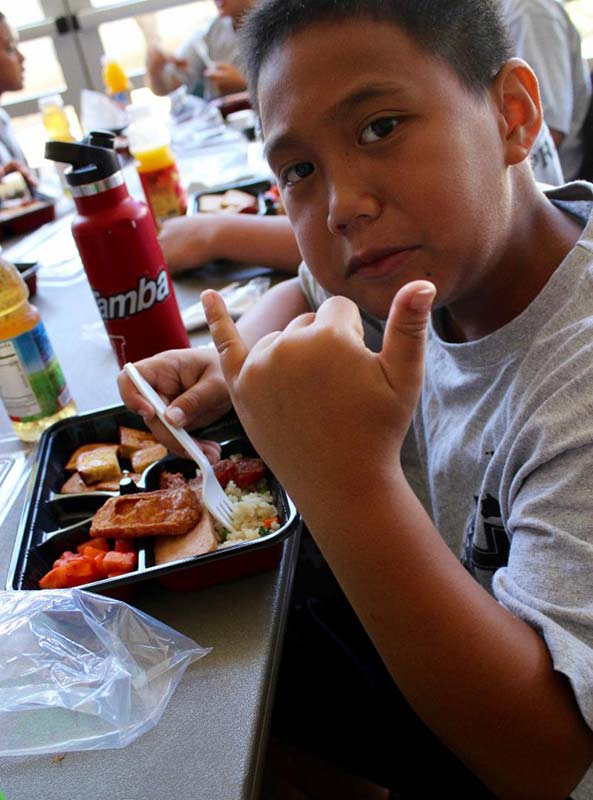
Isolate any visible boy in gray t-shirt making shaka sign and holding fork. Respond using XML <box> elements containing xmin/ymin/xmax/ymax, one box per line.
<box><xmin>121</xmin><ymin>0</ymin><xmax>593</xmax><ymax>800</ymax></box>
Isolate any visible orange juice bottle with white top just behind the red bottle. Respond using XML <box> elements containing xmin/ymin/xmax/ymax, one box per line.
<box><xmin>127</xmin><ymin>105</ymin><xmax>187</xmax><ymax>228</ymax></box>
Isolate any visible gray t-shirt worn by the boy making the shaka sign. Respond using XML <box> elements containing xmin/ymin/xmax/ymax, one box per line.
<box><xmin>300</xmin><ymin>183</ymin><xmax>593</xmax><ymax>800</ymax></box>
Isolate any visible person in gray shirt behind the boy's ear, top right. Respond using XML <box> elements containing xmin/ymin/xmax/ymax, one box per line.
<box><xmin>500</xmin><ymin>0</ymin><xmax>591</xmax><ymax>180</ymax></box>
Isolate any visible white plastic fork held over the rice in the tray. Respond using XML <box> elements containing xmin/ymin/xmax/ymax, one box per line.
<box><xmin>124</xmin><ymin>363</ymin><xmax>233</xmax><ymax>529</ymax></box>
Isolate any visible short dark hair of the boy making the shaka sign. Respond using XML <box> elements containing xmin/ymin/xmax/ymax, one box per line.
<box><xmin>241</xmin><ymin>0</ymin><xmax>512</xmax><ymax>108</ymax></box>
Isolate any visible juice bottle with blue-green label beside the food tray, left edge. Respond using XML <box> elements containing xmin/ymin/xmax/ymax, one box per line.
<box><xmin>0</xmin><ymin>258</ymin><xmax>76</xmax><ymax>442</ymax></box>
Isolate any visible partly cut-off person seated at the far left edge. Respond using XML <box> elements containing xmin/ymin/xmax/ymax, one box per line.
<box><xmin>0</xmin><ymin>11</ymin><xmax>37</xmax><ymax>187</ymax></box>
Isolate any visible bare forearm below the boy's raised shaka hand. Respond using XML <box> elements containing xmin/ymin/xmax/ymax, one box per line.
<box><xmin>291</xmin><ymin>465</ymin><xmax>593</xmax><ymax>800</ymax></box>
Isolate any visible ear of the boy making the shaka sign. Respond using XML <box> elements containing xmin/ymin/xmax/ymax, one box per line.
<box><xmin>492</xmin><ymin>58</ymin><xmax>543</xmax><ymax>166</ymax></box>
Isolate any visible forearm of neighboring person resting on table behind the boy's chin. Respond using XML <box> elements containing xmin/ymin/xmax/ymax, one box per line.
<box><xmin>211</xmin><ymin>214</ymin><xmax>301</xmax><ymax>275</ymax></box>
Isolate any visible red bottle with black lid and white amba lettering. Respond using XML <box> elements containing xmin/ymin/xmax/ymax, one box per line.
<box><xmin>45</xmin><ymin>131</ymin><xmax>189</xmax><ymax>367</ymax></box>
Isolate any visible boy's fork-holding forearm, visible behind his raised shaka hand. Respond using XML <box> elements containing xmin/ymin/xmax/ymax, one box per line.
<box><xmin>237</xmin><ymin>278</ymin><xmax>310</xmax><ymax>348</ymax></box>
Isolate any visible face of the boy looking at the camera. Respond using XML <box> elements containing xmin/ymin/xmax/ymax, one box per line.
<box><xmin>259</xmin><ymin>20</ymin><xmax>511</xmax><ymax>318</ymax></box>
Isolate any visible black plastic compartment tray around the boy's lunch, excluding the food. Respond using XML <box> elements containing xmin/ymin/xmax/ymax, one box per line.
<box><xmin>6</xmin><ymin>406</ymin><xmax>300</xmax><ymax>598</ymax></box>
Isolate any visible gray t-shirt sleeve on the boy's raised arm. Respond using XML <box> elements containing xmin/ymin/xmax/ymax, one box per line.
<box><xmin>492</xmin><ymin>365</ymin><xmax>593</xmax><ymax>800</ymax></box>
